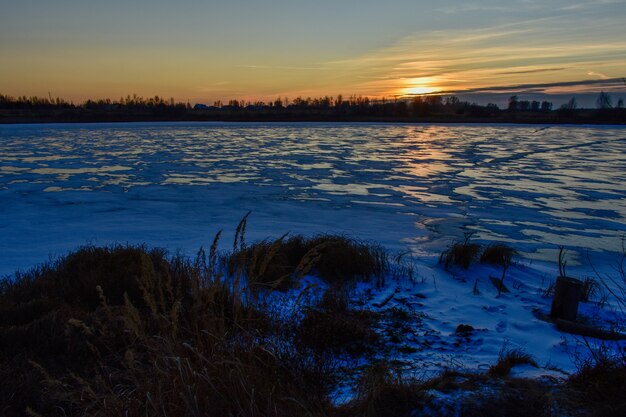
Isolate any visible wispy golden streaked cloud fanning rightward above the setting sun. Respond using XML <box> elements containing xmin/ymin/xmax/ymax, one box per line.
<box><xmin>329</xmin><ymin>11</ymin><xmax>626</xmax><ymax>95</ymax></box>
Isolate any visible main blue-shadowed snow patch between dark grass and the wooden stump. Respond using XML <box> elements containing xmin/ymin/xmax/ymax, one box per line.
<box><xmin>360</xmin><ymin>258</ymin><xmax>576</xmax><ymax>373</ymax></box>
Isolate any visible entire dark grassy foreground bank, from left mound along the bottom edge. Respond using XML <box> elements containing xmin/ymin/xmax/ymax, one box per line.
<box><xmin>0</xmin><ymin>236</ymin><xmax>626</xmax><ymax>417</ymax></box>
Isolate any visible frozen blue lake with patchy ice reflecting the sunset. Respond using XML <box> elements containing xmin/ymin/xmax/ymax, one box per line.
<box><xmin>0</xmin><ymin>123</ymin><xmax>626</xmax><ymax>274</ymax></box>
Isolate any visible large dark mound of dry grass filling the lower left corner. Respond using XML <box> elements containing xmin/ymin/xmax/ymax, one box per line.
<box><xmin>0</xmin><ymin>242</ymin><xmax>329</xmax><ymax>416</ymax></box>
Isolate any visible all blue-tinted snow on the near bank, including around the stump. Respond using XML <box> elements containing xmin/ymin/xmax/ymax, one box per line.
<box><xmin>274</xmin><ymin>247</ymin><xmax>626</xmax><ymax>380</ymax></box>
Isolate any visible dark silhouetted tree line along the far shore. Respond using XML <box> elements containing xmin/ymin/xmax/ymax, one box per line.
<box><xmin>0</xmin><ymin>92</ymin><xmax>626</xmax><ymax>123</ymax></box>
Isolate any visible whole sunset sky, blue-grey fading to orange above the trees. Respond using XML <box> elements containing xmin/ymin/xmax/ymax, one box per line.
<box><xmin>0</xmin><ymin>0</ymin><xmax>626</xmax><ymax>104</ymax></box>
